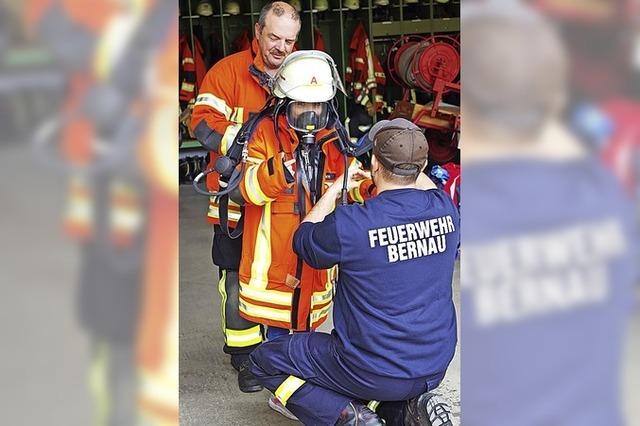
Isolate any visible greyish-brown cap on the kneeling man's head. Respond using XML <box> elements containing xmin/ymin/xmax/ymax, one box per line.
<box><xmin>369</xmin><ymin>118</ymin><xmax>429</xmax><ymax>176</ymax></box>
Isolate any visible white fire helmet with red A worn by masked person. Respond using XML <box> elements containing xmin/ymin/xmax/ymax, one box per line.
<box><xmin>273</xmin><ymin>50</ymin><xmax>344</xmax><ymax>102</ymax></box>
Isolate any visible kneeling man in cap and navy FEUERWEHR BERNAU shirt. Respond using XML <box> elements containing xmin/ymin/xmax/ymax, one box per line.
<box><xmin>251</xmin><ymin>119</ymin><xmax>459</xmax><ymax>425</ymax></box>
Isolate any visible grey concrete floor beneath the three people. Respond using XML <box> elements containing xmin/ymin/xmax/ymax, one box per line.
<box><xmin>180</xmin><ymin>185</ymin><xmax>460</xmax><ymax>426</ymax></box>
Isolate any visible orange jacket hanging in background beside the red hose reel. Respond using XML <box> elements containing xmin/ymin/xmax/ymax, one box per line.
<box><xmin>345</xmin><ymin>22</ymin><xmax>386</xmax><ymax>112</ymax></box>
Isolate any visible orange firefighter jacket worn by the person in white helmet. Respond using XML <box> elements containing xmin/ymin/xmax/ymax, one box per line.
<box><xmin>239</xmin><ymin>116</ymin><xmax>371</xmax><ymax>331</ymax></box>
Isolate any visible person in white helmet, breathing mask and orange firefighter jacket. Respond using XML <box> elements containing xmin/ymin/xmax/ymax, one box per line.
<box><xmin>232</xmin><ymin>50</ymin><xmax>372</xmax><ymax>352</ymax></box>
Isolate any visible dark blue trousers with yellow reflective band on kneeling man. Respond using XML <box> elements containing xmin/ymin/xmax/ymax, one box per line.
<box><xmin>251</xmin><ymin>332</ymin><xmax>441</xmax><ymax>425</ymax></box>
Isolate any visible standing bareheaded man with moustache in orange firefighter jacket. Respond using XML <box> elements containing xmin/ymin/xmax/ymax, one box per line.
<box><xmin>191</xmin><ymin>2</ymin><xmax>300</xmax><ymax>392</ymax></box>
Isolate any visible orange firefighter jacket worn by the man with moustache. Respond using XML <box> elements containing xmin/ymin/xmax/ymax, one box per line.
<box><xmin>191</xmin><ymin>40</ymin><xmax>270</xmax><ymax>228</ymax></box>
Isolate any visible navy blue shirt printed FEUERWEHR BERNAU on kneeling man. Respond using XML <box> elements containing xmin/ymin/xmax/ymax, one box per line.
<box><xmin>293</xmin><ymin>189</ymin><xmax>459</xmax><ymax>378</ymax></box>
